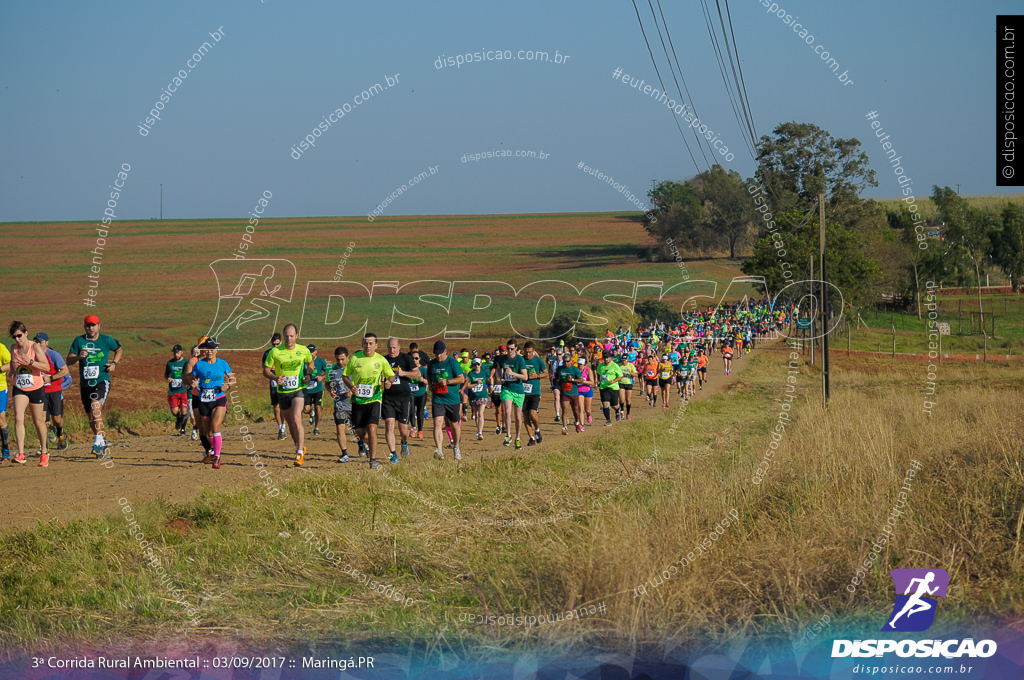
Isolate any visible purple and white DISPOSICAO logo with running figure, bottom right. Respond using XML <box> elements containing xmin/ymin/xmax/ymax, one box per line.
<box><xmin>831</xmin><ymin>569</ymin><xmax>996</xmax><ymax>658</ymax></box>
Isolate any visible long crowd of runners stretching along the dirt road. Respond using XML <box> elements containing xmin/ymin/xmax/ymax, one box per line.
<box><xmin>0</xmin><ymin>300</ymin><xmax>793</xmax><ymax>469</ymax></box>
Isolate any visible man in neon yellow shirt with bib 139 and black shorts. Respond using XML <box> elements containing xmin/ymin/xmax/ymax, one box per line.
<box><xmin>342</xmin><ymin>333</ymin><xmax>398</xmax><ymax>470</ymax></box>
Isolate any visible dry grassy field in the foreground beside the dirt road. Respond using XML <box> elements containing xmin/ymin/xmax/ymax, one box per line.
<box><xmin>0</xmin><ymin>351</ymin><xmax>1024</xmax><ymax>657</ymax></box>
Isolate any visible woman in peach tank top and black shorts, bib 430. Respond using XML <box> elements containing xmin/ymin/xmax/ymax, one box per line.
<box><xmin>8</xmin><ymin>321</ymin><xmax>50</xmax><ymax>467</ymax></box>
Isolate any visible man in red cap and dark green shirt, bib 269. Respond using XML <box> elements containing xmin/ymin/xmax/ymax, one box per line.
<box><xmin>66</xmin><ymin>314</ymin><xmax>124</xmax><ymax>458</ymax></box>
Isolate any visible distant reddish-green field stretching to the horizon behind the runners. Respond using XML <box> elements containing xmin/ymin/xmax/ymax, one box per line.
<box><xmin>5</xmin><ymin>213</ymin><xmax>763</xmax><ymax>357</ymax></box>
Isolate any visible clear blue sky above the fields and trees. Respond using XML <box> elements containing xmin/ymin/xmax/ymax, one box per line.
<box><xmin>0</xmin><ymin>0</ymin><xmax>1019</xmax><ymax>221</ymax></box>
